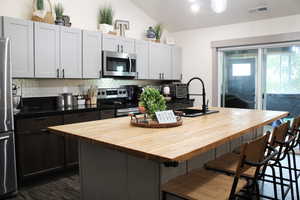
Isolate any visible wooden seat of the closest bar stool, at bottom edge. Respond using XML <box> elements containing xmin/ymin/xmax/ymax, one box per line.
<box><xmin>163</xmin><ymin>169</ymin><xmax>247</xmax><ymax>200</ymax></box>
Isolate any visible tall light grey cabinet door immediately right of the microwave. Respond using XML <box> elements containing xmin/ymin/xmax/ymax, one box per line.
<box><xmin>135</xmin><ymin>41</ymin><xmax>149</xmax><ymax>79</ymax></box>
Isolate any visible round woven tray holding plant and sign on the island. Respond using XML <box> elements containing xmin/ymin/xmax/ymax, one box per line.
<box><xmin>129</xmin><ymin>114</ymin><xmax>183</xmax><ymax>128</ymax></box>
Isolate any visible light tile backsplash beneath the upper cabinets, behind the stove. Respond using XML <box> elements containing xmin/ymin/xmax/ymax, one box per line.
<box><xmin>13</xmin><ymin>78</ymin><xmax>162</xmax><ymax>97</ymax></box>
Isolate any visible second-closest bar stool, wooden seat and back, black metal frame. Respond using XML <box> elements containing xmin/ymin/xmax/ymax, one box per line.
<box><xmin>205</xmin><ymin>123</ymin><xmax>289</xmax><ymax>199</ymax></box>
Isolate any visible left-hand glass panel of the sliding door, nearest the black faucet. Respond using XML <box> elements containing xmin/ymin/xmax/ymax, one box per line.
<box><xmin>222</xmin><ymin>49</ymin><xmax>258</xmax><ymax>109</ymax></box>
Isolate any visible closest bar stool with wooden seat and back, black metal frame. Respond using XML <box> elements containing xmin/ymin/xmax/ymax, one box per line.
<box><xmin>162</xmin><ymin>134</ymin><xmax>277</xmax><ymax>200</ymax></box>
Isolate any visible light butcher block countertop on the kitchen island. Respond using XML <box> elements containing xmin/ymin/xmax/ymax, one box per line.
<box><xmin>49</xmin><ymin>108</ymin><xmax>288</xmax><ymax>162</ymax></box>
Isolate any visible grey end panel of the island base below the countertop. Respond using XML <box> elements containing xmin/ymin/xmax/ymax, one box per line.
<box><xmin>79</xmin><ymin>140</ymin><xmax>161</xmax><ymax>200</ymax></box>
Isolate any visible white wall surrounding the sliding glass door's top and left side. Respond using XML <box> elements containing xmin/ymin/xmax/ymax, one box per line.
<box><xmin>173</xmin><ymin>15</ymin><xmax>300</xmax><ymax>106</ymax></box>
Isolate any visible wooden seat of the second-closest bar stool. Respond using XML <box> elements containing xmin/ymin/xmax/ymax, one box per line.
<box><xmin>205</xmin><ymin>153</ymin><xmax>256</xmax><ymax>178</ymax></box>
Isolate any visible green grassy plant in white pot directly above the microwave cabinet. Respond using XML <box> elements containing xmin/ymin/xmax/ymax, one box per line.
<box><xmin>98</xmin><ymin>6</ymin><xmax>114</xmax><ymax>33</ymax></box>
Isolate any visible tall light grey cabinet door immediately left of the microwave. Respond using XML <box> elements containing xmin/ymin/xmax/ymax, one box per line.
<box><xmin>82</xmin><ymin>31</ymin><xmax>102</xmax><ymax>78</ymax></box>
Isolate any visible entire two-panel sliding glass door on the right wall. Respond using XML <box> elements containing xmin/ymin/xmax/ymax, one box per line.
<box><xmin>219</xmin><ymin>43</ymin><xmax>300</xmax><ymax>116</ymax></box>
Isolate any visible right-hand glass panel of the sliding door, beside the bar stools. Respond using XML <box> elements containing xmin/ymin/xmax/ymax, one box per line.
<box><xmin>263</xmin><ymin>45</ymin><xmax>300</xmax><ymax>117</ymax></box>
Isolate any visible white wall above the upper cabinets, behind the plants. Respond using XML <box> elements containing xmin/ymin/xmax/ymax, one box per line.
<box><xmin>0</xmin><ymin>0</ymin><xmax>156</xmax><ymax>39</ymax></box>
